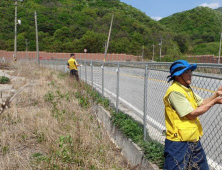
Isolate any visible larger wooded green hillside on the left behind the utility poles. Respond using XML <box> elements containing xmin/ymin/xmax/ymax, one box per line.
<box><xmin>0</xmin><ymin>0</ymin><xmax>165</xmax><ymax>58</ymax></box>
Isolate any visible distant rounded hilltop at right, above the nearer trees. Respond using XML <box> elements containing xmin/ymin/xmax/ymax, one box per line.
<box><xmin>159</xmin><ymin>7</ymin><xmax>222</xmax><ymax>42</ymax></box>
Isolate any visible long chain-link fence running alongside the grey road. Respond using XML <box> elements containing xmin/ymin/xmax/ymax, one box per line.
<box><xmin>41</xmin><ymin>60</ymin><xmax>222</xmax><ymax>170</ymax></box>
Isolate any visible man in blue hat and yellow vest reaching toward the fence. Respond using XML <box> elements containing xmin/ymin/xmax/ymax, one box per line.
<box><xmin>163</xmin><ymin>60</ymin><xmax>222</xmax><ymax>170</ymax></box>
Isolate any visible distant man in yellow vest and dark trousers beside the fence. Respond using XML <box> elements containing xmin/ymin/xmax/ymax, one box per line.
<box><xmin>67</xmin><ymin>53</ymin><xmax>79</xmax><ymax>81</ymax></box>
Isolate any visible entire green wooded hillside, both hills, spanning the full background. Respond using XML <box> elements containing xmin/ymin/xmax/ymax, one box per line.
<box><xmin>0</xmin><ymin>0</ymin><xmax>222</xmax><ymax>60</ymax></box>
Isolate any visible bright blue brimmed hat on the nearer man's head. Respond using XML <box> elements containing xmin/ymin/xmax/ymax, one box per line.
<box><xmin>167</xmin><ymin>60</ymin><xmax>197</xmax><ymax>82</ymax></box>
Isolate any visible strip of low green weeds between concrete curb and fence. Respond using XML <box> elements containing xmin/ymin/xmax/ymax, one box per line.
<box><xmin>76</xmin><ymin>81</ymin><xmax>164</xmax><ymax>168</ymax></box>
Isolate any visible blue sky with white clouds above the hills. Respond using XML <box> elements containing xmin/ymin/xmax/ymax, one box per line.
<box><xmin>120</xmin><ymin>0</ymin><xmax>222</xmax><ymax>20</ymax></box>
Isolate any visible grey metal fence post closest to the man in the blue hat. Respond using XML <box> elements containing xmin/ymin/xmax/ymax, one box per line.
<box><xmin>143</xmin><ymin>65</ymin><xmax>148</xmax><ymax>141</ymax></box>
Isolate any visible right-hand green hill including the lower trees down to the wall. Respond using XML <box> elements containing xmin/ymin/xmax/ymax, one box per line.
<box><xmin>159</xmin><ymin>7</ymin><xmax>222</xmax><ymax>55</ymax></box>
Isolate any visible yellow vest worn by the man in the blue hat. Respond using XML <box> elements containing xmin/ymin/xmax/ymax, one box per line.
<box><xmin>163</xmin><ymin>81</ymin><xmax>203</xmax><ymax>142</ymax></box>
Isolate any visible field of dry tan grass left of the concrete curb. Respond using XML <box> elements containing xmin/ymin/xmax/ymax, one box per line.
<box><xmin>0</xmin><ymin>63</ymin><xmax>131</xmax><ymax>170</ymax></box>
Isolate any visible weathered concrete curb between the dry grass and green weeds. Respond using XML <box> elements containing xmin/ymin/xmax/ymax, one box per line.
<box><xmin>95</xmin><ymin>105</ymin><xmax>159</xmax><ymax>170</ymax></box>
